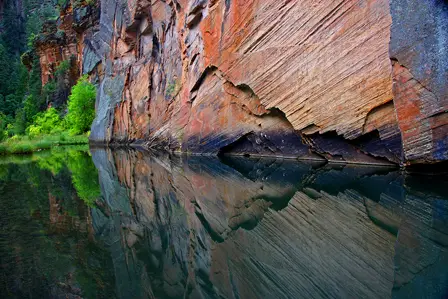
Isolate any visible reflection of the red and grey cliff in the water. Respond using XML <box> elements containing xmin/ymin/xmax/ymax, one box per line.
<box><xmin>92</xmin><ymin>149</ymin><xmax>448</xmax><ymax>298</ymax></box>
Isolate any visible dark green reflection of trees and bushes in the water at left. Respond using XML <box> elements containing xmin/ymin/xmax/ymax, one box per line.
<box><xmin>0</xmin><ymin>150</ymin><xmax>115</xmax><ymax>298</ymax></box>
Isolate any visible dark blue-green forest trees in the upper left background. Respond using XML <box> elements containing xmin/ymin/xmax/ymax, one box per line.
<box><xmin>0</xmin><ymin>0</ymin><xmax>58</xmax><ymax>134</ymax></box>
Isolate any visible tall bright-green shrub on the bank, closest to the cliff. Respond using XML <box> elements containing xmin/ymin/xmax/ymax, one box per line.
<box><xmin>66</xmin><ymin>76</ymin><xmax>96</xmax><ymax>135</ymax></box>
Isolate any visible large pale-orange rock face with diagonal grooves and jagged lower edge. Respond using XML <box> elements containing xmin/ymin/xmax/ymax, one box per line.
<box><xmin>201</xmin><ymin>1</ymin><xmax>392</xmax><ymax>139</ymax></box>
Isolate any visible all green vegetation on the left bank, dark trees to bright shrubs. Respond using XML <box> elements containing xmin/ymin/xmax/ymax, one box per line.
<box><xmin>0</xmin><ymin>0</ymin><xmax>96</xmax><ymax>155</ymax></box>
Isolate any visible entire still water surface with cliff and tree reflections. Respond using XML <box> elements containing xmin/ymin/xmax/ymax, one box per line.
<box><xmin>0</xmin><ymin>148</ymin><xmax>448</xmax><ymax>298</ymax></box>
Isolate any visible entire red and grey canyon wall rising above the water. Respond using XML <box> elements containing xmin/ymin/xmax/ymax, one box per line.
<box><xmin>40</xmin><ymin>0</ymin><xmax>448</xmax><ymax>165</ymax></box>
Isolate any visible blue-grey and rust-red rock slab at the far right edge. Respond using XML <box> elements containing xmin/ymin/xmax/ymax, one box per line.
<box><xmin>390</xmin><ymin>0</ymin><xmax>448</xmax><ymax>163</ymax></box>
